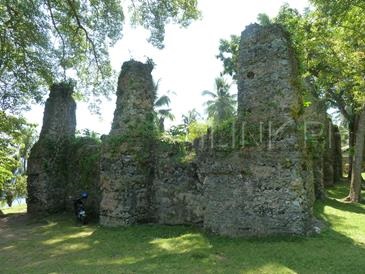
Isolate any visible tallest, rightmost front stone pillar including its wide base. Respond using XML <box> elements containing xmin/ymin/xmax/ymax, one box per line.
<box><xmin>201</xmin><ymin>24</ymin><xmax>314</xmax><ymax>235</ymax></box>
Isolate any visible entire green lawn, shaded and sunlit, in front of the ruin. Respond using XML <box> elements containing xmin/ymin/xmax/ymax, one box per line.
<box><xmin>0</xmin><ymin>185</ymin><xmax>365</xmax><ymax>274</ymax></box>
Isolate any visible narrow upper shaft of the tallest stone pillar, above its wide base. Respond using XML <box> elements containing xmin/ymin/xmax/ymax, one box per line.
<box><xmin>238</xmin><ymin>24</ymin><xmax>300</xmax><ymax>129</ymax></box>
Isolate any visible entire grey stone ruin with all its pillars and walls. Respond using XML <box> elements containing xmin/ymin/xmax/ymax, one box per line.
<box><xmin>28</xmin><ymin>24</ymin><xmax>342</xmax><ymax>236</ymax></box>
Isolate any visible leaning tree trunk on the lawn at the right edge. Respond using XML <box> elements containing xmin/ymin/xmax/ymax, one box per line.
<box><xmin>347</xmin><ymin>107</ymin><xmax>365</xmax><ymax>203</ymax></box>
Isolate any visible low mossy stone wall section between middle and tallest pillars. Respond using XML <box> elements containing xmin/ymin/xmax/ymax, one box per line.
<box><xmin>153</xmin><ymin>143</ymin><xmax>204</xmax><ymax>225</ymax></box>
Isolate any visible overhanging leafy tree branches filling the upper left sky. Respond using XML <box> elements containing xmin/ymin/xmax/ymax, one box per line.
<box><xmin>0</xmin><ymin>0</ymin><xmax>200</xmax><ymax>112</ymax></box>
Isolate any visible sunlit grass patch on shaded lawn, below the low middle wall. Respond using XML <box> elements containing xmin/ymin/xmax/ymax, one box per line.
<box><xmin>150</xmin><ymin>234</ymin><xmax>212</xmax><ymax>253</ymax></box>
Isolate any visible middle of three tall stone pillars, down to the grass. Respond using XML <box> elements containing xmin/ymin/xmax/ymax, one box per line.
<box><xmin>100</xmin><ymin>60</ymin><xmax>155</xmax><ymax>226</ymax></box>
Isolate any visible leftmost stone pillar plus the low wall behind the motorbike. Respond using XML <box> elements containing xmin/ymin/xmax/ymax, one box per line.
<box><xmin>27</xmin><ymin>83</ymin><xmax>100</xmax><ymax>216</ymax></box>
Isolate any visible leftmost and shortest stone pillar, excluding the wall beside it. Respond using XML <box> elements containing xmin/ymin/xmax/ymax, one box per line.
<box><xmin>27</xmin><ymin>83</ymin><xmax>76</xmax><ymax>214</ymax></box>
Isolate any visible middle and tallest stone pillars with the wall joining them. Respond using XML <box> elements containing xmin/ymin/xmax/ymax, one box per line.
<box><xmin>100</xmin><ymin>25</ymin><xmax>320</xmax><ymax>236</ymax></box>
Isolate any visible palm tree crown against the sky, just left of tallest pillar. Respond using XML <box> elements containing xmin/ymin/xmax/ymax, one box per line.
<box><xmin>202</xmin><ymin>77</ymin><xmax>236</xmax><ymax>123</ymax></box>
